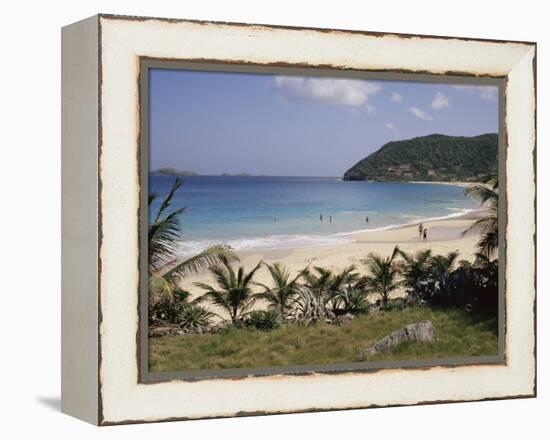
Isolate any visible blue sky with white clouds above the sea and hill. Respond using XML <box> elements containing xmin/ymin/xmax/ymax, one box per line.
<box><xmin>149</xmin><ymin>69</ymin><xmax>498</xmax><ymax>176</ymax></box>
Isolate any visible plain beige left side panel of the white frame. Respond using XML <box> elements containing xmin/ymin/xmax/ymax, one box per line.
<box><xmin>61</xmin><ymin>17</ymin><xmax>99</xmax><ymax>424</ymax></box>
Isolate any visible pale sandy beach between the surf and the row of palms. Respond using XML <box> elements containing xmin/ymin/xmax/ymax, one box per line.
<box><xmin>181</xmin><ymin>211</ymin><xmax>483</xmax><ymax>312</ymax></box>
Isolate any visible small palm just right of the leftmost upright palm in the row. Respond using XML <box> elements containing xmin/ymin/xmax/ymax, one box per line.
<box><xmin>258</xmin><ymin>263</ymin><xmax>307</xmax><ymax>318</ymax></box>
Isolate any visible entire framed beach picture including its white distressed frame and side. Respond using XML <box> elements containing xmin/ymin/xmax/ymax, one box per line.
<box><xmin>62</xmin><ymin>15</ymin><xmax>536</xmax><ymax>425</ymax></box>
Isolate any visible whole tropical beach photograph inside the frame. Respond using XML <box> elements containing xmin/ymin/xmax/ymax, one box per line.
<box><xmin>147</xmin><ymin>69</ymin><xmax>500</xmax><ymax>372</ymax></box>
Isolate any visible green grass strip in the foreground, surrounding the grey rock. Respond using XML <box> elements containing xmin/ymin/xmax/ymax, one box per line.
<box><xmin>149</xmin><ymin>308</ymin><xmax>498</xmax><ymax>371</ymax></box>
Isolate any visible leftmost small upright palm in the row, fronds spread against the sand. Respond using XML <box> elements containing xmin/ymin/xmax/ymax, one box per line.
<box><xmin>195</xmin><ymin>257</ymin><xmax>262</xmax><ymax>324</ymax></box>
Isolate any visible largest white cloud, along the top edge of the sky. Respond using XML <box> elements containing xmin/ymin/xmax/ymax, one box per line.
<box><xmin>274</xmin><ymin>76</ymin><xmax>382</xmax><ymax>109</ymax></box>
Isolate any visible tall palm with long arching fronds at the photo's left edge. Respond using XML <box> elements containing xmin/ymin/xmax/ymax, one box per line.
<box><xmin>148</xmin><ymin>178</ymin><xmax>238</xmax><ymax>308</ymax></box>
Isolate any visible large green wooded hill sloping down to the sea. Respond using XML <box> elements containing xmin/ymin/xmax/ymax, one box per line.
<box><xmin>343</xmin><ymin>133</ymin><xmax>498</xmax><ymax>182</ymax></box>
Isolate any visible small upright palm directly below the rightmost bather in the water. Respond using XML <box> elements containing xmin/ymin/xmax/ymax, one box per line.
<box><xmin>363</xmin><ymin>246</ymin><xmax>401</xmax><ymax>308</ymax></box>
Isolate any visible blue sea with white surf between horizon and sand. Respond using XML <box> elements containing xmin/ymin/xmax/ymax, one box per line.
<box><xmin>149</xmin><ymin>176</ymin><xmax>478</xmax><ymax>256</ymax></box>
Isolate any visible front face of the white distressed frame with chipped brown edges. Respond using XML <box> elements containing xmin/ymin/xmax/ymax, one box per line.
<box><xmin>62</xmin><ymin>16</ymin><xmax>536</xmax><ymax>424</ymax></box>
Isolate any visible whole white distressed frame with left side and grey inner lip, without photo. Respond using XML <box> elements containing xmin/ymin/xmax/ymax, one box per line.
<box><xmin>62</xmin><ymin>15</ymin><xmax>536</xmax><ymax>425</ymax></box>
